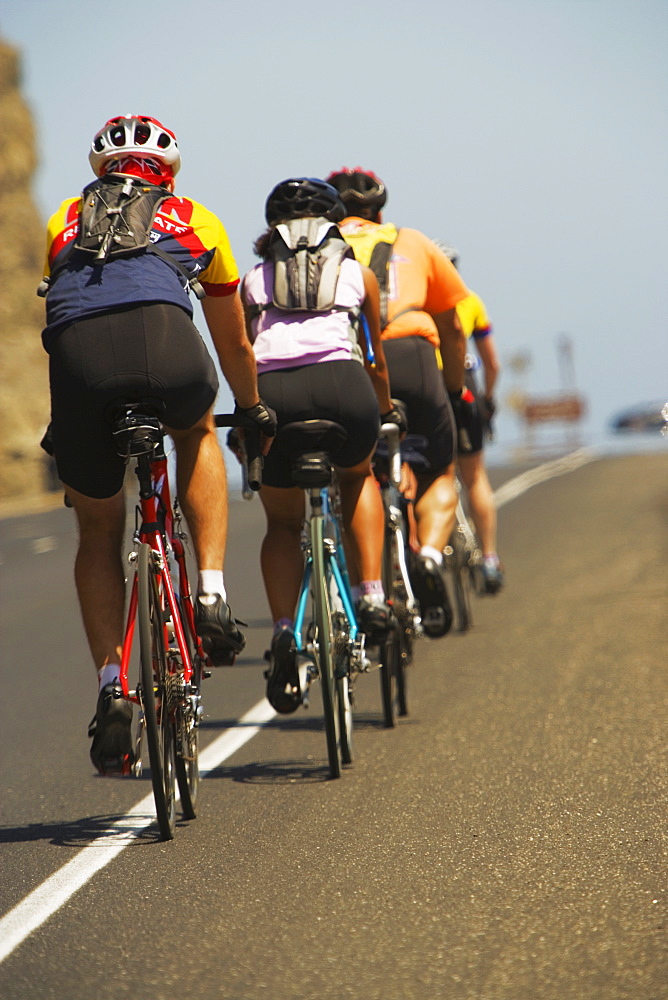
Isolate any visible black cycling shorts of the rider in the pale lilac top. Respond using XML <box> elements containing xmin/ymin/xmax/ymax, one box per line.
<box><xmin>258</xmin><ymin>361</ymin><xmax>380</xmax><ymax>487</ymax></box>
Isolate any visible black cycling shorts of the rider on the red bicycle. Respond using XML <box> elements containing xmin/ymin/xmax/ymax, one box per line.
<box><xmin>49</xmin><ymin>303</ymin><xmax>218</xmax><ymax>499</ymax></box>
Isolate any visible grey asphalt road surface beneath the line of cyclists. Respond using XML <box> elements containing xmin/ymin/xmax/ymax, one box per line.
<box><xmin>0</xmin><ymin>455</ymin><xmax>668</xmax><ymax>1000</ymax></box>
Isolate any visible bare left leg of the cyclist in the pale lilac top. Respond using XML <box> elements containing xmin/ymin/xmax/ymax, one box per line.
<box><xmin>260</xmin><ymin>486</ymin><xmax>304</xmax><ymax>622</ymax></box>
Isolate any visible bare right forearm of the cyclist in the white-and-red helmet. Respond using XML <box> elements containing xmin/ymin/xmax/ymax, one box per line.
<box><xmin>202</xmin><ymin>291</ymin><xmax>260</xmax><ymax>409</ymax></box>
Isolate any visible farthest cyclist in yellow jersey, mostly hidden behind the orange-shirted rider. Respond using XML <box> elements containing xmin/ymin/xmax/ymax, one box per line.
<box><xmin>434</xmin><ymin>240</ymin><xmax>504</xmax><ymax>594</ymax></box>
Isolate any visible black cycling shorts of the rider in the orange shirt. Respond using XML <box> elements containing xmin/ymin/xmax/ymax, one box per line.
<box><xmin>383</xmin><ymin>337</ymin><xmax>455</xmax><ymax>474</ymax></box>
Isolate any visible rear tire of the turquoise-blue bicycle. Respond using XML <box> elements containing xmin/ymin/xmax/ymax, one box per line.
<box><xmin>311</xmin><ymin>517</ymin><xmax>341</xmax><ymax>778</ymax></box>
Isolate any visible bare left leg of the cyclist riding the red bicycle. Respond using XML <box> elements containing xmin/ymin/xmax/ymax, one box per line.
<box><xmin>67</xmin><ymin>486</ymin><xmax>125</xmax><ymax>669</ymax></box>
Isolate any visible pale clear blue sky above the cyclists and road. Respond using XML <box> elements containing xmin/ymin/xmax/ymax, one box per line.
<box><xmin>0</xmin><ymin>0</ymin><xmax>668</xmax><ymax>446</ymax></box>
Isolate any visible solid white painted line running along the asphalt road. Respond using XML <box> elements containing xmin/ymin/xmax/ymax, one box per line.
<box><xmin>0</xmin><ymin>448</ymin><xmax>597</xmax><ymax>962</ymax></box>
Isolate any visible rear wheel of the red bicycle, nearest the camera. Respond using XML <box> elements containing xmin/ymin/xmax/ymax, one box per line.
<box><xmin>137</xmin><ymin>542</ymin><xmax>176</xmax><ymax>840</ymax></box>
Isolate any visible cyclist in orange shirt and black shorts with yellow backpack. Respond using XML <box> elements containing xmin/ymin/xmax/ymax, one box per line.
<box><xmin>327</xmin><ymin>167</ymin><xmax>469</xmax><ymax>636</ymax></box>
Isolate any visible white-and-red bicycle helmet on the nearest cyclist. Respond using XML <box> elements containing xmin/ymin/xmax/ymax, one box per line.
<box><xmin>88</xmin><ymin>115</ymin><xmax>181</xmax><ymax>177</ymax></box>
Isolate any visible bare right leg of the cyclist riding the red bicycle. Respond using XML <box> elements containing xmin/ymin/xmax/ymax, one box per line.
<box><xmin>169</xmin><ymin>412</ymin><xmax>227</xmax><ymax>570</ymax></box>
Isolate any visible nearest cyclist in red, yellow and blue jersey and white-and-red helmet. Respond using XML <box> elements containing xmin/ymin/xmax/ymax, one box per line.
<box><xmin>40</xmin><ymin>115</ymin><xmax>275</xmax><ymax>773</ymax></box>
